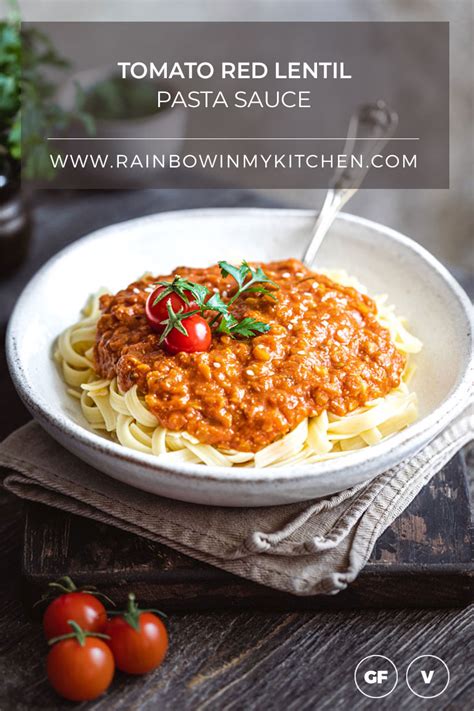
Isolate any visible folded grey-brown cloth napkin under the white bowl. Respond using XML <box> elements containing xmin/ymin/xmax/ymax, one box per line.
<box><xmin>0</xmin><ymin>406</ymin><xmax>474</xmax><ymax>595</ymax></box>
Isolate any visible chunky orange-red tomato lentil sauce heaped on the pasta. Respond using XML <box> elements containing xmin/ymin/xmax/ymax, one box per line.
<box><xmin>95</xmin><ymin>259</ymin><xmax>405</xmax><ymax>452</ymax></box>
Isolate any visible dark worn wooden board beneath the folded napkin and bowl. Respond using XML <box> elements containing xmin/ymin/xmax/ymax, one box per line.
<box><xmin>23</xmin><ymin>456</ymin><xmax>473</xmax><ymax>611</ymax></box>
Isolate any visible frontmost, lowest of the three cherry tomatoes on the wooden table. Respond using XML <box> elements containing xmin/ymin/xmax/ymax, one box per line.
<box><xmin>46</xmin><ymin>628</ymin><xmax>115</xmax><ymax>701</ymax></box>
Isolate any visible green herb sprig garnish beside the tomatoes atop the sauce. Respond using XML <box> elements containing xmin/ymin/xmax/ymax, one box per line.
<box><xmin>153</xmin><ymin>261</ymin><xmax>279</xmax><ymax>343</ymax></box>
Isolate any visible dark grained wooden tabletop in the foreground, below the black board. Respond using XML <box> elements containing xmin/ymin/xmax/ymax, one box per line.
<box><xmin>0</xmin><ymin>493</ymin><xmax>474</xmax><ymax>711</ymax></box>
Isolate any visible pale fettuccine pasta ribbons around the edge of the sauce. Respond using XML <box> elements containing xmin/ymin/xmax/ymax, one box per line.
<box><xmin>54</xmin><ymin>271</ymin><xmax>421</xmax><ymax>468</ymax></box>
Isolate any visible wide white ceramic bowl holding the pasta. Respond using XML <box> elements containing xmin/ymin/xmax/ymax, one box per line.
<box><xmin>7</xmin><ymin>209</ymin><xmax>473</xmax><ymax>506</ymax></box>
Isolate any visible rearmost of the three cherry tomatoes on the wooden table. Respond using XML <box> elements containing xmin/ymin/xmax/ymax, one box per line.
<box><xmin>43</xmin><ymin>576</ymin><xmax>107</xmax><ymax>639</ymax></box>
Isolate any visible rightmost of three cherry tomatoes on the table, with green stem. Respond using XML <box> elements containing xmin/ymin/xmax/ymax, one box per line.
<box><xmin>105</xmin><ymin>595</ymin><xmax>168</xmax><ymax>674</ymax></box>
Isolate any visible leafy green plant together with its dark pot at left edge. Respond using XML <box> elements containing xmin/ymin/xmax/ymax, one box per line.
<box><xmin>0</xmin><ymin>14</ymin><xmax>94</xmax><ymax>274</ymax></box>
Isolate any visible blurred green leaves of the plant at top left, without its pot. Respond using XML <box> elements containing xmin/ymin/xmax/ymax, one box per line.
<box><xmin>0</xmin><ymin>7</ymin><xmax>95</xmax><ymax>179</ymax></box>
